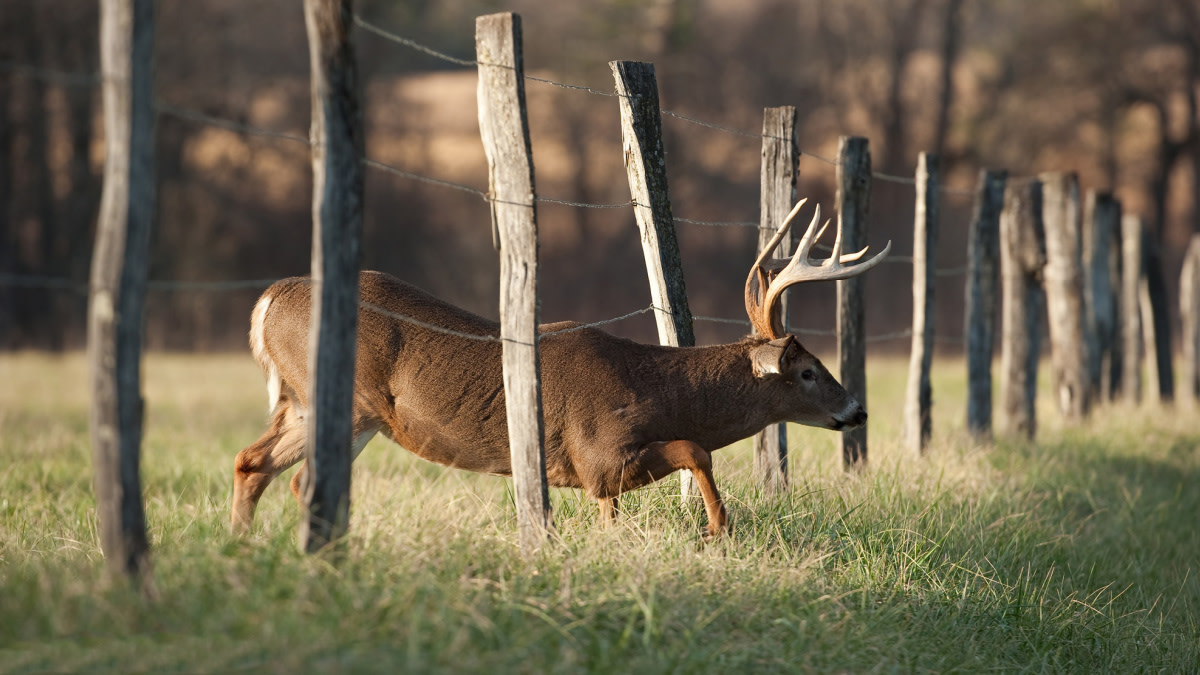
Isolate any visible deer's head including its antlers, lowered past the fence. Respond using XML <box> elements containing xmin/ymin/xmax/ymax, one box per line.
<box><xmin>745</xmin><ymin>199</ymin><xmax>892</xmax><ymax>429</ymax></box>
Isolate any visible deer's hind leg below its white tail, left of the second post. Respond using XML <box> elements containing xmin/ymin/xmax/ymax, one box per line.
<box><xmin>229</xmin><ymin>396</ymin><xmax>307</xmax><ymax>532</ymax></box>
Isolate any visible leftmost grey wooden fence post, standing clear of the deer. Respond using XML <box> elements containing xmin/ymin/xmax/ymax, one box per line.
<box><xmin>88</xmin><ymin>0</ymin><xmax>156</xmax><ymax>592</ymax></box>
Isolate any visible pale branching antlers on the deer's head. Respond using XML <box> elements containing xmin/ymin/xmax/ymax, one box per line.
<box><xmin>745</xmin><ymin>198</ymin><xmax>892</xmax><ymax>340</ymax></box>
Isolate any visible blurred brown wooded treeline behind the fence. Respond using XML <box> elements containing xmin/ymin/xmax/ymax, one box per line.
<box><xmin>0</xmin><ymin>0</ymin><xmax>1200</xmax><ymax>350</ymax></box>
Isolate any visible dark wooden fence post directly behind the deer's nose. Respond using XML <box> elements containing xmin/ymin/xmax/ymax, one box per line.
<box><xmin>838</xmin><ymin>136</ymin><xmax>871</xmax><ymax>471</ymax></box>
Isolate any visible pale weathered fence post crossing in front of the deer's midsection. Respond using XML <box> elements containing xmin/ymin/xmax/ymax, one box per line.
<box><xmin>475</xmin><ymin>12</ymin><xmax>553</xmax><ymax>554</ymax></box>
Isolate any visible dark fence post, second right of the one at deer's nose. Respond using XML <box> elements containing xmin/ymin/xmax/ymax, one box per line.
<box><xmin>965</xmin><ymin>171</ymin><xmax>1008</xmax><ymax>438</ymax></box>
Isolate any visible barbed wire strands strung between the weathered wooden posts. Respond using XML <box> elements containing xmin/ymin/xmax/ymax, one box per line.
<box><xmin>0</xmin><ymin>16</ymin><xmax>984</xmax><ymax>345</ymax></box>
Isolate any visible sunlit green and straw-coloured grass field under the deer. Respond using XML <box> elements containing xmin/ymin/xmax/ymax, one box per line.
<box><xmin>0</xmin><ymin>354</ymin><xmax>1200</xmax><ymax>674</ymax></box>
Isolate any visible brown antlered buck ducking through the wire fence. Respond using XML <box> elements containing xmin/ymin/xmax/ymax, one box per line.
<box><xmin>230</xmin><ymin>199</ymin><xmax>892</xmax><ymax>539</ymax></box>
